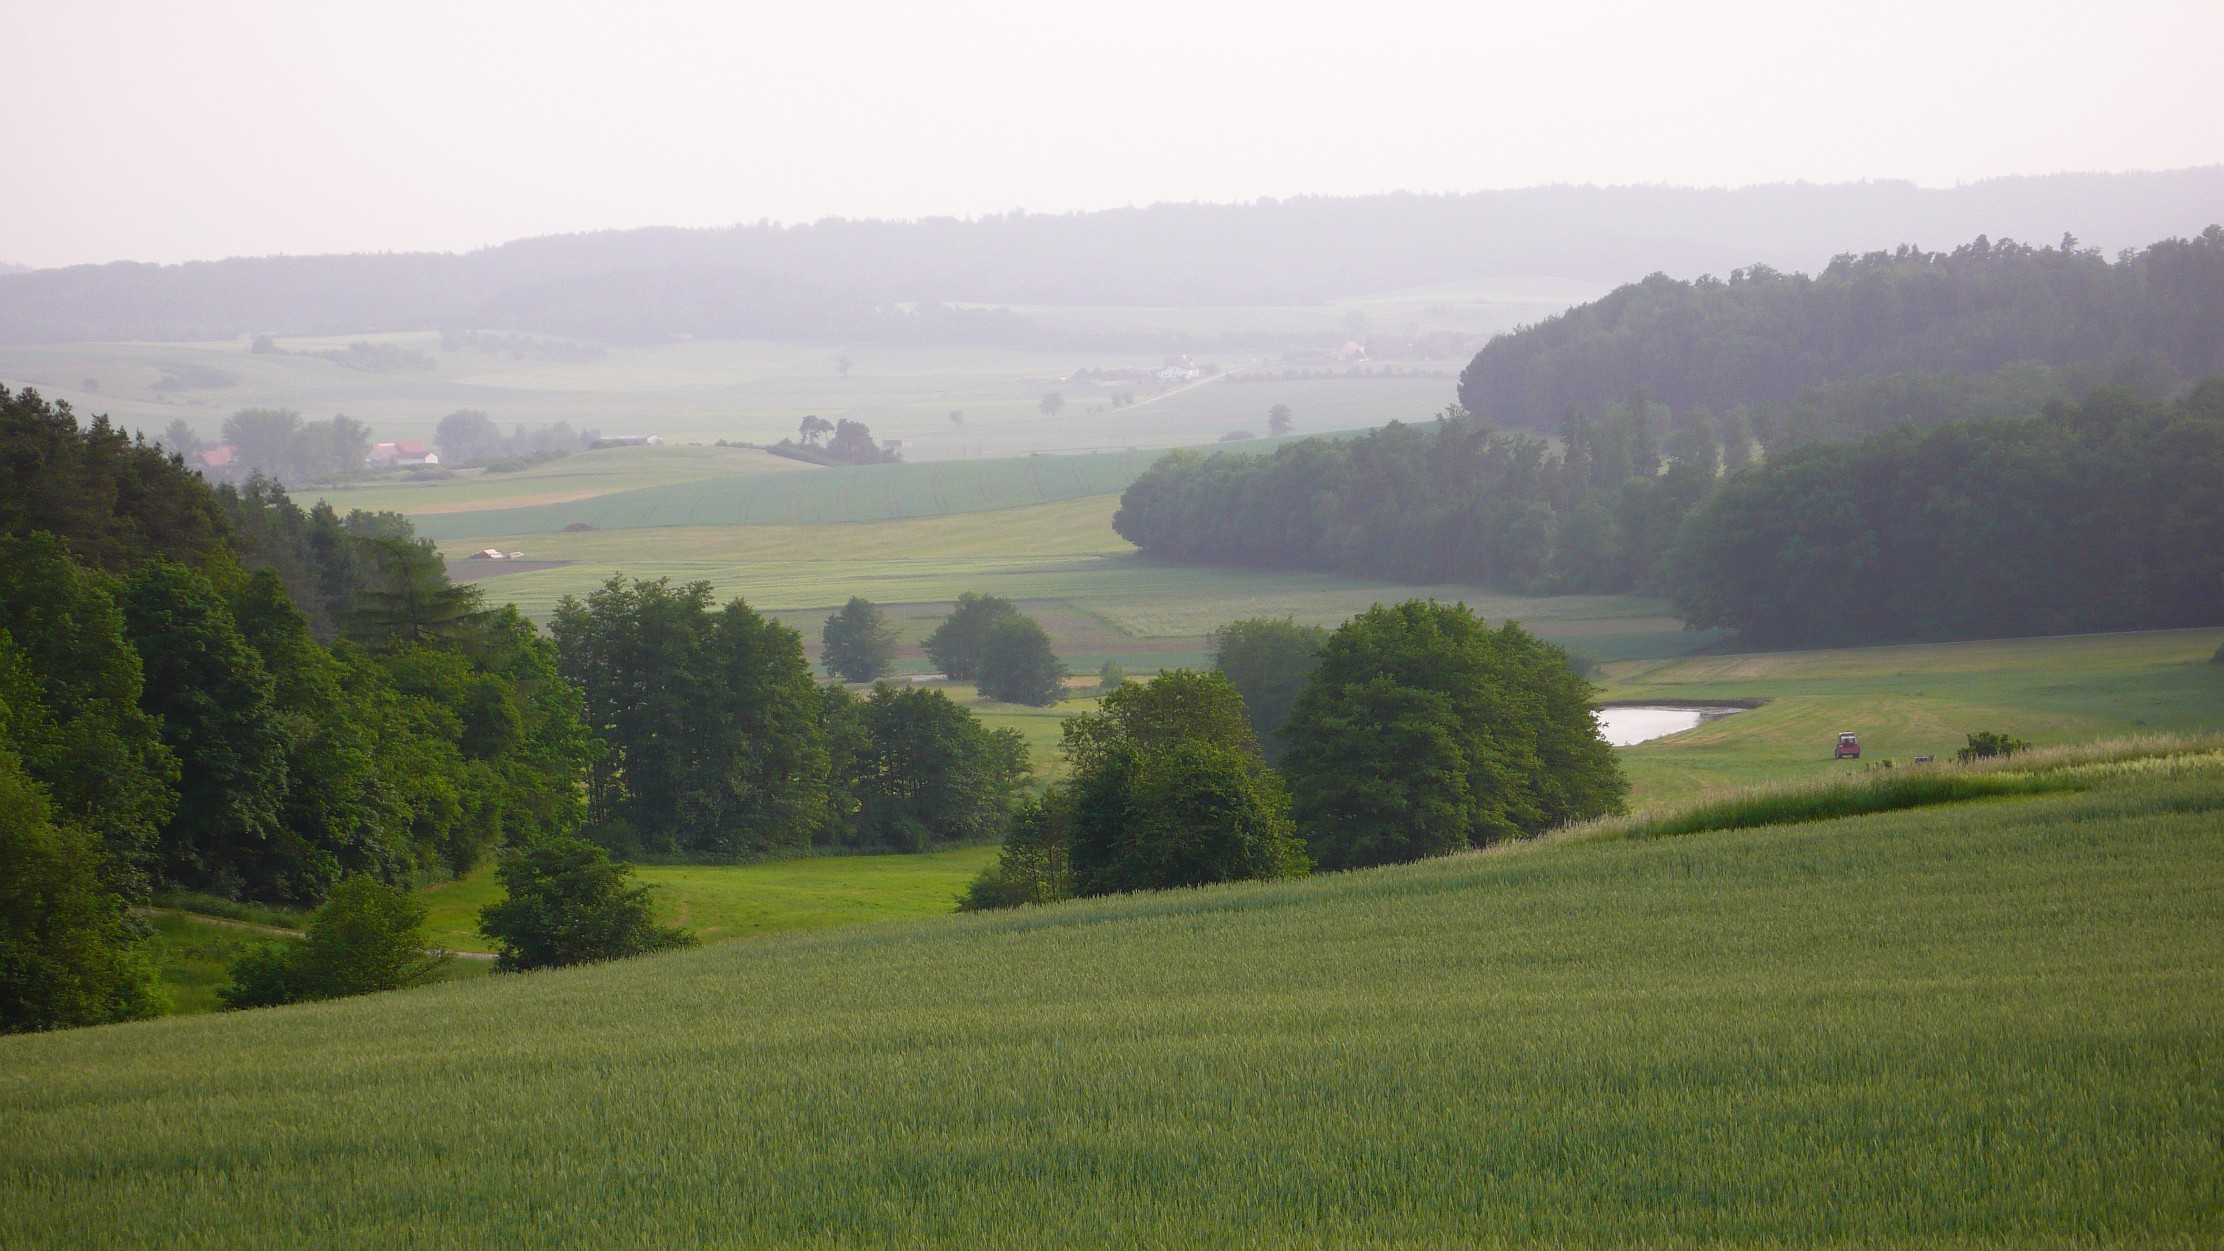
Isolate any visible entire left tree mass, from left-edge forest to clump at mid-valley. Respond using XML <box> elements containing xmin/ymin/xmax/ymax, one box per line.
<box><xmin>0</xmin><ymin>390</ymin><xmax>1049</xmax><ymax>1033</ymax></box>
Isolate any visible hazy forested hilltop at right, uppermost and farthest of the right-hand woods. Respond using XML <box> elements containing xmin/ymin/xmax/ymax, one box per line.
<box><xmin>1459</xmin><ymin>225</ymin><xmax>2224</xmax><ymax>430</ymax></box>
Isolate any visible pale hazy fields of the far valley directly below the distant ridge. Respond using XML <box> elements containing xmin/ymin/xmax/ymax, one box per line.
<box><xmin>0</xmin><ymin>322</ymin><xmax>1485</xmax><ymax>461</ymax></box>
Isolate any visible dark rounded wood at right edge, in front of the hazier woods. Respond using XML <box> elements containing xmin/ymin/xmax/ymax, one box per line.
<box><xmin>1666</xmin><ymin>378</ymin><xmax>2224</xmax><ymax>643</ymax></box>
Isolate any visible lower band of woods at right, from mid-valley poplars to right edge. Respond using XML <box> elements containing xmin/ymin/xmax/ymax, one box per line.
<box><xmin>1114</xmin><ymin>378</ymin><xmax>2224</xmax><ymax>643</ymax></box>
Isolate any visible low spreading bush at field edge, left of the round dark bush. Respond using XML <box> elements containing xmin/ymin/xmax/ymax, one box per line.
<box><xmin>218</xmin><ymin>873</ymin><xmax>445</xmax><ymax>1008</ymax></box>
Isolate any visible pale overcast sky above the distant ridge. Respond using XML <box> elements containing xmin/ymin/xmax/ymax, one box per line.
<box><xmin>0</xmin><ymin>0</ymin><xmax>2224</xmax><ymax>265</ymax></box>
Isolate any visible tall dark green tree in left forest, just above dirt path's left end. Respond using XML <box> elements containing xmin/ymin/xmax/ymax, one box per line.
<box><xmin>122</xmin><ymin>559</ymin><xmax>293</xmax><ymax>899</ymax></box>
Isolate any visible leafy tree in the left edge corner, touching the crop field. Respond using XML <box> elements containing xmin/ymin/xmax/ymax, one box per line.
<box><xmin>0</xmin><ymin>716</ymin><xmax>158</xmax><ymax>1033</ymax></box>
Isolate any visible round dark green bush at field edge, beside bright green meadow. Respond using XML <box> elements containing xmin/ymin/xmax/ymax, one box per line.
<box><xmin>478</xmin><ymin>837</ymin><xmax>694</xmax><ymax>973</ymax></box>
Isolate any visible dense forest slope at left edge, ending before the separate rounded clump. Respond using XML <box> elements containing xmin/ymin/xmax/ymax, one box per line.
<box><xmin>0</xmin><ymin>390</ymin><xmax>594</xmax><ymax>1028</ymax></box>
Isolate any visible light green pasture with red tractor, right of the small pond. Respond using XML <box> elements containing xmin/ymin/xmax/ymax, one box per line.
<box><xmin>1604</xmin><ymin>630</ymin><xmax>2224</xmax><ymax>806</ymax></box>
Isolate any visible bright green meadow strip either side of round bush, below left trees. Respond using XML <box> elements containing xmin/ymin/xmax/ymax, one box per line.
<box><xmin>418</xmin><ymin>846</ymin><xmax>996</xmax><ymax>950</ymax></box>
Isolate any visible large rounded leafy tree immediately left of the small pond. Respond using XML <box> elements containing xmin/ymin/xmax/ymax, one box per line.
<box><xmin>1283</xmin><ymin>601</ymin><xmax>1628</xmax><ymax>868</ymax></box>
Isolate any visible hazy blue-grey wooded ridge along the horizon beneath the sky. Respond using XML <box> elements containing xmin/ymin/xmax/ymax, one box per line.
<box><xmin>0</xmin><ymin>167</ymin><xmax>2224</xmax><ymax>343</ymax></box>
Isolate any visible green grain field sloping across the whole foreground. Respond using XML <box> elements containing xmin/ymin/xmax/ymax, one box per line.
<box><xmin>0</xmin><ymin>768</ymin><xmax>2224</xmax><ymax>1247</ymax></box>
